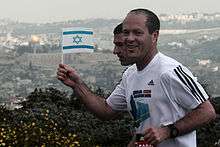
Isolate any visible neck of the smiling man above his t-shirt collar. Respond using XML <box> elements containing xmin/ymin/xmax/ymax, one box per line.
<box><xmin>136</xmin><ymin>48</ymin><xmax>158</xmax><ymax>71</ymax></box>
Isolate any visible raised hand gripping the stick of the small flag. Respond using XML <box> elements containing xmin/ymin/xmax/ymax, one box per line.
<box><xmin>57</xmin><ymin>64</ymin><xmax>82</xmax><ymax>88</ymax></box>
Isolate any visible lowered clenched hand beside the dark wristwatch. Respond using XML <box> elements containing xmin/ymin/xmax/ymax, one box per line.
<box><xmin>144</xmin><ymin>127</ymin><xmax>170</xmax><ymax>145</ymax></box>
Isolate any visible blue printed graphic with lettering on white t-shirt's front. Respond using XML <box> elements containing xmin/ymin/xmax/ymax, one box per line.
<box><xmin>130</xmin><ymin>90</ymin><xmax>151</xmax><ymax>127</ymax></box>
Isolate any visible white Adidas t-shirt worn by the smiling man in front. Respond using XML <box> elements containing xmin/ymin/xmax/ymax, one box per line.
<box><xmin>107</xmin><ymin>53</ymin><xmax>208</xmax><ymax>147</ymax></box>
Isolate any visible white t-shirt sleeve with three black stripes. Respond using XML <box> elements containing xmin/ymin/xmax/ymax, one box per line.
<box><xmin>161</xmin><ymin>65</ymin><xmax>209</xmax><ymax>110</ymax></box>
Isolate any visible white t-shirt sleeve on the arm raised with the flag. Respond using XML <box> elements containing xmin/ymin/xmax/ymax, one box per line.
<box><xmin>106</xmin><ymin>73</ymin><xmax>127</xmax><ymax>111</ymax></box>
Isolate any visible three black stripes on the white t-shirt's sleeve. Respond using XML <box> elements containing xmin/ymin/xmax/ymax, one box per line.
<box><xmin>174</xmin><ymin>66</ymin><xmax>206</xmax><ymax>103</ymax></box>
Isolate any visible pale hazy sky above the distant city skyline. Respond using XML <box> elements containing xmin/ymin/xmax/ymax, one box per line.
<box><xmin>0</xmin><ymin>0</ymin><xmax>220</xmax><ymax>22</ymax></box>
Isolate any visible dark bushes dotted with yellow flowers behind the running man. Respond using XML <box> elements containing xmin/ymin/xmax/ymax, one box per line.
<box><xmin>0</xmin><ymin>88</ymin><xmax>220</xmax><ymax>147</ymax></box>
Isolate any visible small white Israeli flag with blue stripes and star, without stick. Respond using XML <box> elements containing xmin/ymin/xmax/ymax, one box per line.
<box><xmin>62</xmin><ymin>27</ymin><xmax>94</xmax><ymax>53</ymax></box>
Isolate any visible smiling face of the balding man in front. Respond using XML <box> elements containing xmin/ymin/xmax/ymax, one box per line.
<box><xmin>123</xmin><ymin>13</ymin><xmax>155</xmax><ymax>64</ymax></box>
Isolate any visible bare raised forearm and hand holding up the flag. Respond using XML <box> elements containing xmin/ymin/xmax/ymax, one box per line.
<box><xmin>57</xmin><ymin>64</ymin><xmax>119</xmax><ymax>120</ymax></box>
